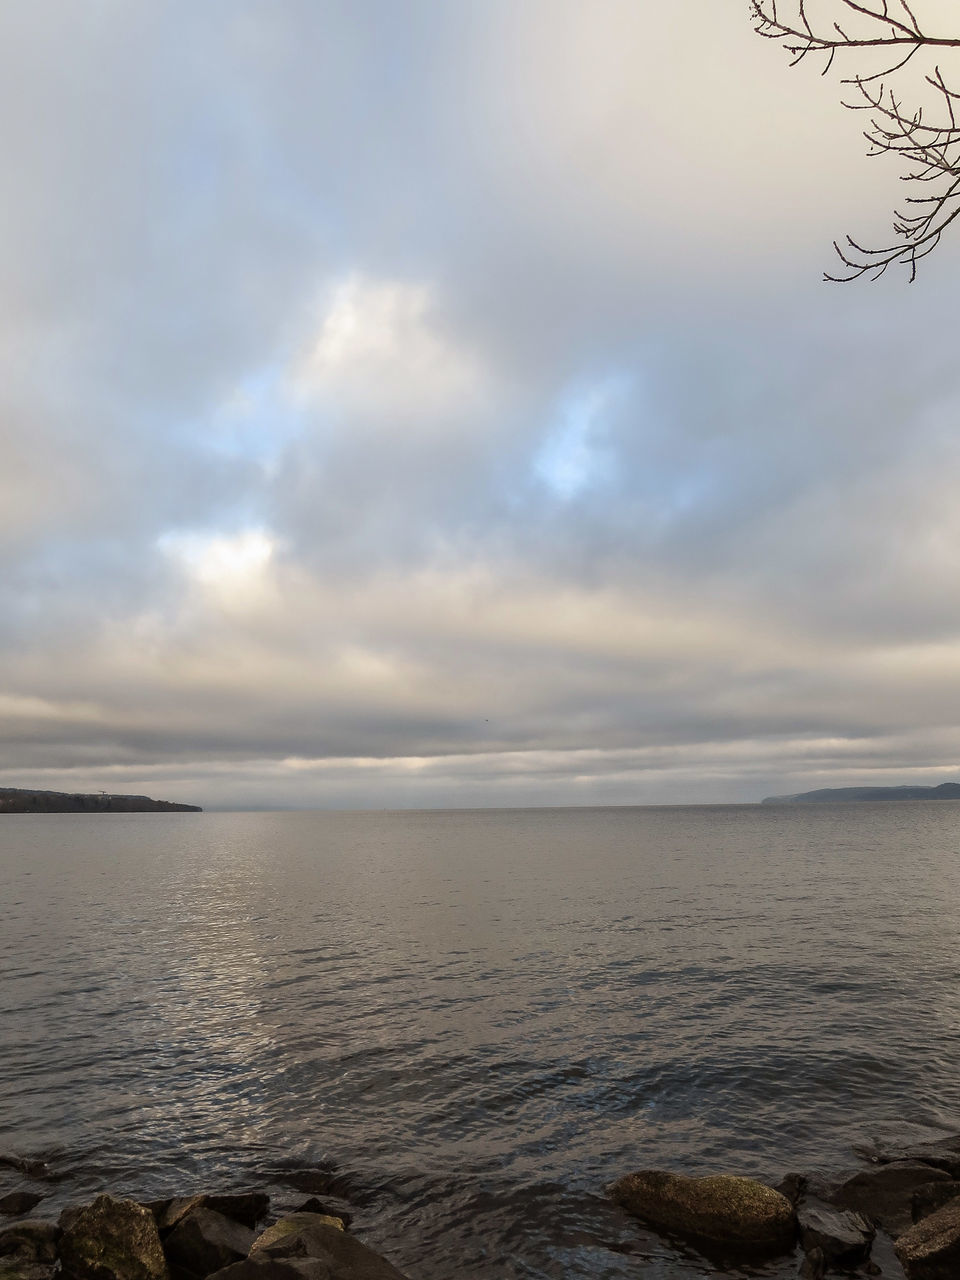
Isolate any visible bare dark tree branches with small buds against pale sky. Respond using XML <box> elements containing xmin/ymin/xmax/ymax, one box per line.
<box><xmin>750</xmin><ymin>0</ymin><xmax>960</xmax><ymax>280</ymax></box>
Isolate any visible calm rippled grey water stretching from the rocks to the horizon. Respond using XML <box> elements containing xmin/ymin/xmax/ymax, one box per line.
<box><xmin>0</xmin><ymin>803</ymin><xmax>960</xmax><ymax>1280</ymax></box>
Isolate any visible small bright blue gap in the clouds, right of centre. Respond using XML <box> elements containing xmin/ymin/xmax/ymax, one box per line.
<box><xmin>534</xmin><ymin>375</ymin><xmax>632</xmax><ymax>502</ymax></box>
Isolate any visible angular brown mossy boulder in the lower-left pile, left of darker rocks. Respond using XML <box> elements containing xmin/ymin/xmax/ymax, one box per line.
<box><xmin>60</xmin><ymin>1196</ymin><xmax>168</xmax><ymax>1280</ymax></box>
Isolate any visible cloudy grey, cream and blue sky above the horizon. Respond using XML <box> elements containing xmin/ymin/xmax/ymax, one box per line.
<box><xmin>0</xmin><ymin>0</ymin><xmax>960</xmax><ymax>808</ymax></box>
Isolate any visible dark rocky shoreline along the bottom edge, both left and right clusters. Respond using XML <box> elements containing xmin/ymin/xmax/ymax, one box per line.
<box><xmin>0</xmin><ymin>1135</ymin><xmax>960</xmax><ymax>1280</ymax></box>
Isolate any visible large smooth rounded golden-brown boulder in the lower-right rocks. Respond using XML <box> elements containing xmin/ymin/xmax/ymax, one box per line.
<box><xmin>611</xmin><ymin>1169</ymin><xmax>796</xmax><ymax>1251</ymax></box>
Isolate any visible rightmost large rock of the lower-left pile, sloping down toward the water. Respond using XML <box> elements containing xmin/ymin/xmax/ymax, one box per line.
<box><xmin>244</xmin><ymin>1213</ymin><xmax>403</xmax><ymax>1280</ymax></box>
